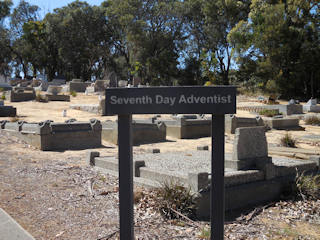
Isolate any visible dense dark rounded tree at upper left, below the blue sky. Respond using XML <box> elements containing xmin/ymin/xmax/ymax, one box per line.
<box><xmin>44</xmin><ymin>1</ymin><xmax>110</xmax><ymax>80</ymax></box>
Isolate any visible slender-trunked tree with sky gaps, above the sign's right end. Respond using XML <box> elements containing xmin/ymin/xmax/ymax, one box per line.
<box><xmin>180</xmin><ymin>0</ymin><xmax>250</xmax><ymax>85</ymax></box>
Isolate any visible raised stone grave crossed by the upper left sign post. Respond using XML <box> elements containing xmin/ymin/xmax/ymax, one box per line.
<box><xmin>102</xmin><ymin>119</ymin><xmax>166</xmax><ymax>145</ymax></box>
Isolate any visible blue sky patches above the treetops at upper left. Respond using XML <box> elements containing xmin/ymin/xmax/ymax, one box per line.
<box><xmin>12</xmin><ymin>0</ymin><xmax>103</xmax><ymax>16</ymax></box>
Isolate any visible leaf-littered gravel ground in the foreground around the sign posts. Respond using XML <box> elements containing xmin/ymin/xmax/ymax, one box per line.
<box><xmin>0</xmin><ymin>132</ymin><xmax>320</xmax><ymax>240</ymax></box>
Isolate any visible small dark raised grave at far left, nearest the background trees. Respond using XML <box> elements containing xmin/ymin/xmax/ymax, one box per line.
<box><xmin>5</xmin><ymin>87</ymin><xmax>36</xmax><ymax>102</ymax></box>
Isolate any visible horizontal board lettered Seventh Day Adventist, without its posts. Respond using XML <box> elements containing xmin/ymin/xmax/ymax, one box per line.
<box><xmin>106</xmin><ymin>86</ymin><xmax>236</xmax><ymax>115</ymax></box>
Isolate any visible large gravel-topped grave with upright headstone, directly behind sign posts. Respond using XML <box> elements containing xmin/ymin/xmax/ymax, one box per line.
<box><xmin>87</xmin><ymin>127</ymin><xmax>320</xmax><ymax>219</ymax></box>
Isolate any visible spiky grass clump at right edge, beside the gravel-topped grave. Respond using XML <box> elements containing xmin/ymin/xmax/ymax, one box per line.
<box><xmin>295</xmin><ymin>173</ymin><xmax>320</xmax><ymax>200</ymax></box>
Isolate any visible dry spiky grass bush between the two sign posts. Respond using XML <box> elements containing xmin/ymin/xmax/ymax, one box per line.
<box><xmin>156</xmin><ymin>182</ymin><xmax>195</xmax><ymax>219</ymax></box>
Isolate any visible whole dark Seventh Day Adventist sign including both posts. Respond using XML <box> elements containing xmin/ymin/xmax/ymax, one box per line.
<box><xmin>105</xmin><ymin>86</ymin><xmax>236</xmax><ymax>240</ymax></box>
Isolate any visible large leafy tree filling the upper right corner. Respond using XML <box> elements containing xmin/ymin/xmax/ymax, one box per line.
<box><xmin>229</xmin><ymin>0</ymin><xmax>320</xmax><ymax>97</ymax></box>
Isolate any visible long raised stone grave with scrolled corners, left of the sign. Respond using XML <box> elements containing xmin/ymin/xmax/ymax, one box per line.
<box><xmin>0</xmin><ymin>119</ymin><xmax>101</xmax><ymax>151</ymax></box>
